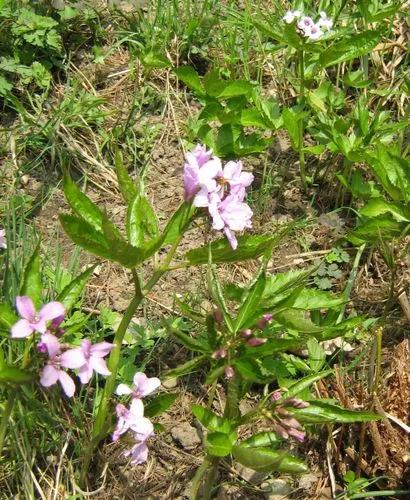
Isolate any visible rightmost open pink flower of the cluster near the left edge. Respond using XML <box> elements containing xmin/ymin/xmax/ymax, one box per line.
<box><xmin>63</xmin><ymin>339</ymin><xmax>114</xmax><ymax>384</ymax></box>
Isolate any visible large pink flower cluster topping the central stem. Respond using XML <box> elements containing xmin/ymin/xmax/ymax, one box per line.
<box><xmin>184</xmin><ymin>145</ymin><xmax>253</xmax><ymax>250</ymax></box>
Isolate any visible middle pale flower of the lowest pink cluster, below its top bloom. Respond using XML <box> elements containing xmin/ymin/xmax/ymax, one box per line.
<box><xmin>112</xmin><ymin>399</ymin><xmax>154</xmax><ymax>442</ymax></box>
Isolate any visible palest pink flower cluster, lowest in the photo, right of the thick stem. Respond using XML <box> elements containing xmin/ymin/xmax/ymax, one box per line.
<box><xmin>112</xmin><ymin>372</ymin><xmax>161</xmax><ymax>465</ymax></box>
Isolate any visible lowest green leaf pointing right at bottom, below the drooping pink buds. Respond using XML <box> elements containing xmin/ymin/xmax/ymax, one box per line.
<box><xmin>232</xmin><ymin>444</ymin><xmax>308</xmax><ymax>474</ymax></box>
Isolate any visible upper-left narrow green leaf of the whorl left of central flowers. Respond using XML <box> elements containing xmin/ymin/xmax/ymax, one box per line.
<box><xmin>63</xmin><ymin>174</ymin><xmax>103</xmax><ymax>231</ymax></box>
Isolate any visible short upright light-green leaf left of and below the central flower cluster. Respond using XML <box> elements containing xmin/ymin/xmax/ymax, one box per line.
<box><xmin>127</xmin><ymin>195</ymin><xmax>159</xmax><ymax>247</ymax></box>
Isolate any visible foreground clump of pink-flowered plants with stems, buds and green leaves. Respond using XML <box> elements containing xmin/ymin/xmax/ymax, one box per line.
<box><xmin>0</xmin><ymin>145</ymin><xmax>376</xmax><ymax>498</ymax></box>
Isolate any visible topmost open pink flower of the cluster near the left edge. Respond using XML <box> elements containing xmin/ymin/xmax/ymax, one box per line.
<box><xmin>11</xmin><ymin>296</ymin><xmax>65</xmax><ymax>339</ymax></box>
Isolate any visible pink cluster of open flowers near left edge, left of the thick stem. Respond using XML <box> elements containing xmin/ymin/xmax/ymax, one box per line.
<box><xmin>11</xmin><ymin>296</ymin><xmax>114</xmax><ymax>397</ymax></box>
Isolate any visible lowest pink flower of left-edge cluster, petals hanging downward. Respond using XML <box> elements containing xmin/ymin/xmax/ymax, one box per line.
<box><xmin>39</xmin><ymin>333</ymin><xmax>80</xmax><ymax>397</ymax></box>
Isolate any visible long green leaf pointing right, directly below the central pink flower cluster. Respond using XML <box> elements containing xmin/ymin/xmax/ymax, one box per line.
<box><xmin>185</xmin><ymin>226</ymin><xmax>294</xmax><ymax>265</ymax></box>
